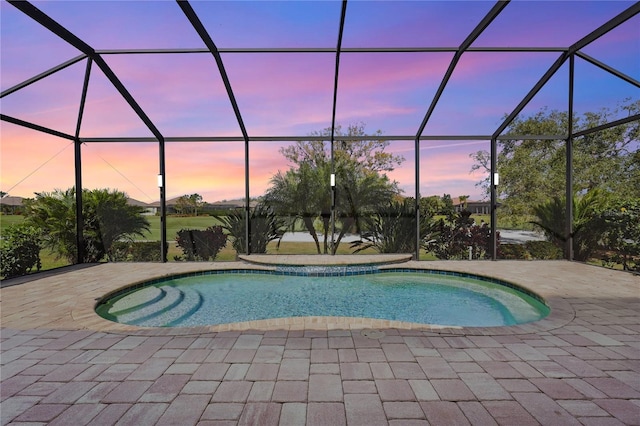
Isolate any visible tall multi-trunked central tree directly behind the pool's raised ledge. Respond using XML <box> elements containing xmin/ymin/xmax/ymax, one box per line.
<box><xmin>264</xmin><ymin>124</ymin><xmax>404</xmax><ymax>254</ymax></box>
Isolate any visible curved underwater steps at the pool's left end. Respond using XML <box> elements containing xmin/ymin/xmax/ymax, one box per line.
<box><xmin>109</xmin><ymin>286</ymin><xmax>202</xmax><ymax>327</ymax></box>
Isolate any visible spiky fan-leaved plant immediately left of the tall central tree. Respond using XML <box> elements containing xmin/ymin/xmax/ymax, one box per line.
<box><xmin>215</xmin><ymin>203</ymin><xmax>286</xmax><ymax>254</ymax></box>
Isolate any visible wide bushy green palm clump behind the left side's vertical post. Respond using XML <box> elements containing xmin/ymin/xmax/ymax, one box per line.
<box><xmin>25</xmin><ymin>188</ymin><xmax>149</xmax><ymax>263</ymax></box>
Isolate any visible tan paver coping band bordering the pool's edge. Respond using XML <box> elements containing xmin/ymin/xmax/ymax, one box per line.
<box><xmin>65</xmin><ymin>256</ymin><xmax>575</xmax><ymax>336</ymax></box>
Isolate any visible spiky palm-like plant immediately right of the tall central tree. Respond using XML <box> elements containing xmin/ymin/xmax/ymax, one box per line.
<box><xmin>351</xmin><ymin>198</ymin><xmax>433</xmax><ymax>253</ymax></box>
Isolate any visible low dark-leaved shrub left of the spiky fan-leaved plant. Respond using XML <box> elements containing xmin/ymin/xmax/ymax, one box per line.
<box><xmin>176</xmin><ymin>225</ymin><xmax>227</xmax><ymax>261</ymax></box>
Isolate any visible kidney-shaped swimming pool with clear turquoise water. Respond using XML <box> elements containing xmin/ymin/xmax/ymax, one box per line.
<box><xmin>96</xmin><ymin>267</ymin><xmax>549</xmax><ymax>327</ymax></box>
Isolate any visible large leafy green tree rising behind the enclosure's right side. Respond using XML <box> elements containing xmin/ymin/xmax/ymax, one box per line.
<box><xmin>471</xmin><ymin>100</ymin><xmax>640</xmax><ymax>220</ymax></box>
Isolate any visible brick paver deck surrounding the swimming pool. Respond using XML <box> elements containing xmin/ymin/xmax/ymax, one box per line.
<box><xmin>0</xmin><ymin>256</ymin><xmax>640</xmax><ymax>426</ymax></box>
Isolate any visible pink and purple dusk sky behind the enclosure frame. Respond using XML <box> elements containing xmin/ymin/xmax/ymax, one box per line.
<box><xmin>0</xmin><ymin>1</ymin><xmax>640</xmax><ymax>202</ymax></box>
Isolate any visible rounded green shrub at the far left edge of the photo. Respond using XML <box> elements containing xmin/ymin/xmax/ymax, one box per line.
<box><xmin>0</xmin><ymin>224</ymin><xmax>42</xmax><ymax>278</ymax></box>
